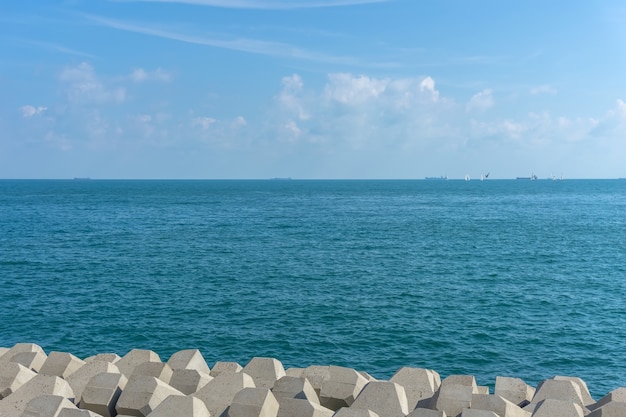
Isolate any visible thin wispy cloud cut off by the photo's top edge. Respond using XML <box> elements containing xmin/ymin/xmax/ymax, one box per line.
<box><xmin>113</xmin><ymin>0</ymin><xmax>391</xmax><ymax>10</ymax></box>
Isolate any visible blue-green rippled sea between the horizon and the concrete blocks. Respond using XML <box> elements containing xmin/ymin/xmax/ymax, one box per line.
<box><xmin>0</xmin><ymin>179</ymin><xmax>626</xmax><ymax>400</ymax></box>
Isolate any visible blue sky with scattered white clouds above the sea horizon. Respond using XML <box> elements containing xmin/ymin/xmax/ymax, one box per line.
<box><xmin>0</xmin><ymin>0</ymin><xmax>626</xmax><ymax>178</ymax></box>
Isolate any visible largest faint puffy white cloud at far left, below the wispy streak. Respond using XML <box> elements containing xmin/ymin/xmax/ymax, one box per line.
<box><xmin>59</xmin><ymin>62</ymin><xmax>126</xmax><ymax>103</ymax></box>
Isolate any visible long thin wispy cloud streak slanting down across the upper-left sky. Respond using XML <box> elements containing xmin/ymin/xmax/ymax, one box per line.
<box><xmin>82</xmin><ymin>14</ymin><xmax>359</xmax><ymax>65</ymax></box>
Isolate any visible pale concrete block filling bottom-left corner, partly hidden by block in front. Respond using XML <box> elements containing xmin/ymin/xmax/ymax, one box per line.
<box><xmin>0</xmin><ymin>375</ymin><xmax>75</xmax><ymax>417</ymax></box>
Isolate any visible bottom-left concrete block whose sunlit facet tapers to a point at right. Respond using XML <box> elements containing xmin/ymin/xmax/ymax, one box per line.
<box><xmin>115</xmin><ymin>375</ymin><xmax>184</xmax><ymax>417</ymax></box>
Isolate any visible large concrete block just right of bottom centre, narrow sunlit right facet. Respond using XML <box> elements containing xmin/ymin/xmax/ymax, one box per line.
<box><xmin>319</xmin><ymin>366</ymin><xmax>368</xmax><ymax>410</ymax></box>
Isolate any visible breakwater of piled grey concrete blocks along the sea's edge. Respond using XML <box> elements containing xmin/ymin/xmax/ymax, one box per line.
<box><xmin>0</xmin><ymin>343</ymin><xmax>626</xmax><ymax>417</ymax></box>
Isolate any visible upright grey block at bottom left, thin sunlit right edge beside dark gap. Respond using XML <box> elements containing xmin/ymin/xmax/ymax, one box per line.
<box><xmin>79</xmin><ymin>372</ymin><xmax>128</xmax><ymax>417</ymax></box>
